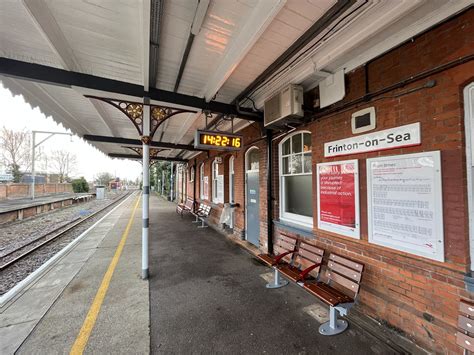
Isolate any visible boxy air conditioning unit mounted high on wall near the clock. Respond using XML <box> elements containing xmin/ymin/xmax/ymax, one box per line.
<box><xmin>264</xmin><ymin>85</ymin><xmax>304</xmax><ymax>127</ymax></box>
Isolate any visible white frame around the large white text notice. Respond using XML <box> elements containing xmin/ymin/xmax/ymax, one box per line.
<box><xmin>366</xmin><ymin>150</ymin><xmax>445</xmax><ymax>262</ymax></box>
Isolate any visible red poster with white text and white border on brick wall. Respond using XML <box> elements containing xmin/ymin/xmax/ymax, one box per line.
<box><xmin>316</xmin><ymin>160</ymin><xmax>360</xmax><ymax>239</ymax></box>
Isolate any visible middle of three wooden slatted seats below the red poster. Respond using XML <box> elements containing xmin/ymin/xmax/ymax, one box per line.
<box><xmin>278</xmin><ymin>241</ymin><xmax>324</xmax><ymax>286</ymax></box>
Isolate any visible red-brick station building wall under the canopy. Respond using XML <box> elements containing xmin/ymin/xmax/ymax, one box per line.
<box><xmin>188</xmin><ymin>9</ymin><xmax>474</xmax><ymax>353</ymax></box>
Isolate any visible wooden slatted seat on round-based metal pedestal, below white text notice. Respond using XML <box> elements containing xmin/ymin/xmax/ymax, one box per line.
<box><xmin>303</xmin><ymin>254</ymin><xmax>364</xmax><ymax>335</ymax></box>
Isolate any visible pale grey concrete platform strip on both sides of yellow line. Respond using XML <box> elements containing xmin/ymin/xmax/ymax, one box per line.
<box><xmin>0</xmin><ymin>194</ymin><xmax>149</xmax><ymax>354</ymax></box>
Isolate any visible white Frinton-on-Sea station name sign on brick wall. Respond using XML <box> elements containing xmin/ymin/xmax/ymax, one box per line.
<box><xmin>324</xmin><ymin>122</ymin><xmax>421</xmax><ymax>158</ymax></box>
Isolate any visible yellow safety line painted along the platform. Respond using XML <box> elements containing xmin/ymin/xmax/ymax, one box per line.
<box><xmin>69</xmin><ymin>196</ymin><xmax>140</xmax><ymax>355</ymax></box>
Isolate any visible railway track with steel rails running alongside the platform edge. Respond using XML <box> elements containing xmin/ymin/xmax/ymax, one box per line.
<box><xmin>0</xmin><ymin>192</ymin><xmax>133</xmax><ymax>271</ymax></box>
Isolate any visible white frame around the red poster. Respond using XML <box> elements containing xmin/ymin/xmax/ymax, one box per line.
<box><xmin>316</xmin><ymin>159</ymin><xmax>360</xmax><ymax>239</ymax></box>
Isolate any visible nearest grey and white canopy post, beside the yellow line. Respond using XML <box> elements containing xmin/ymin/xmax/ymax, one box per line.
<box><xmin>142</xmin><ymin>98</ymin><xmax>150</xmax><ymax>280</ymax></box>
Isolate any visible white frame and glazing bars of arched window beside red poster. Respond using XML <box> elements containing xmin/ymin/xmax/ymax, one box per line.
<box><xmin>278</xmin><ymin>131</ymin><xmax>314</xmax><ymax>228</ymax></box>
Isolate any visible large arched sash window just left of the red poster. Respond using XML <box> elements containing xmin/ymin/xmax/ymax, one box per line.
<box><xmin>279</xmin><ymin>132</ymin><xmax>313</xmax><ymax>227</ymax></box>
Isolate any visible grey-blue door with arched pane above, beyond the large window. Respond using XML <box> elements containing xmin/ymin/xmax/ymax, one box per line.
<box><xmin>245</xmin><ymin>148</ymin><xmax>260</xmax><ymax>247</ymax></box>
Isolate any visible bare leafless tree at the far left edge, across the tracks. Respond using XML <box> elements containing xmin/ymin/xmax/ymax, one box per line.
<box><xmin>0</xmin><ymin>127</ymin><xmax>31</xmax><ymax>182</ymax></box>
